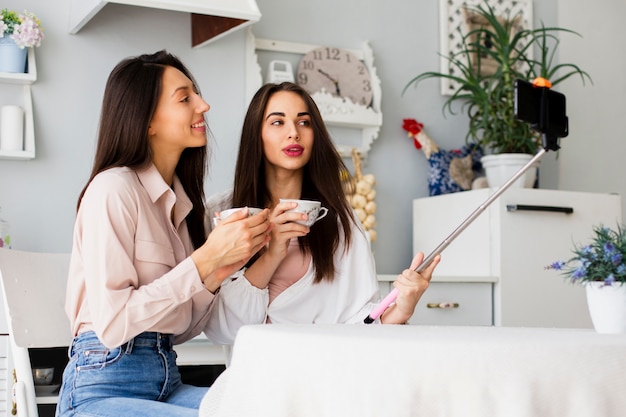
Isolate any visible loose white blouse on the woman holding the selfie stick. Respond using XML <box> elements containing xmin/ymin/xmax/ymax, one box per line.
<box><xmin>205</xmin><ymin>191</ymin><xmax>380</xmax><ymax>344</ymax></box>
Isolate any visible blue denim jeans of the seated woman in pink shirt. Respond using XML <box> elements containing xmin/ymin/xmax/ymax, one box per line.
<box><xmin>56</xmin><ymin>332</ymin><xmax>208</xmax><ymax>417</ymax></box>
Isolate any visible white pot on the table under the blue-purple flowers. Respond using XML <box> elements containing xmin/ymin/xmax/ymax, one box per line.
<box><xmin>585</xmin><ymin>282</ymin><xmax>626</xmax><ymax>333</ymax></box>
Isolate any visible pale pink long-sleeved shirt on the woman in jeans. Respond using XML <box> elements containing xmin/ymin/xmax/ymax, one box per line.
<box><xmin>66</xmin><ymin>165</ymin><xmax>214</xmax><ymax>348</ymax></box>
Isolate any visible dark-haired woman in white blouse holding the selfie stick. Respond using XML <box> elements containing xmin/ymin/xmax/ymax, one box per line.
<box><xmin>206</xmin><ymin>82</ymin><xmax>439</xmax><ymax>343</ymax></box>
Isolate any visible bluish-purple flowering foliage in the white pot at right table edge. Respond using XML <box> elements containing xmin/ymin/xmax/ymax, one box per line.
<box><xmin>546</xmin><ymin>225</ymin><xmax>626</xmax><ymax>285</ymax></box>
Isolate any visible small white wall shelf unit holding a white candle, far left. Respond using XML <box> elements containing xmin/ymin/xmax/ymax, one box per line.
<box><xmin>0</xmin><ymin>48</ymin><xmax>37</xmax><ymax>160</ymax></box>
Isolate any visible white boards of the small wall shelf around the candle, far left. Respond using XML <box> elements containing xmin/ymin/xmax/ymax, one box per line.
<box><xmin>0</xmin><ymin>48</ymin><xmax>37</xmax><ymax>160</ymax></box>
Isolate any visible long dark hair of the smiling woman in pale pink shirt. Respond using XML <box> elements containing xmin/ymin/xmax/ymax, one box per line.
<box><xmin>77</xmin><ymin>51</ymin><xmax>208</xmax><ymax>248</ymax></box>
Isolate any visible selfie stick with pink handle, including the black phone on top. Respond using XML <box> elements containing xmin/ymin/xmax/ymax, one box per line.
<box><xmin>363</xmin><ymin>80</ymin><xmax>568</xmax><ymax>324</ymax></box>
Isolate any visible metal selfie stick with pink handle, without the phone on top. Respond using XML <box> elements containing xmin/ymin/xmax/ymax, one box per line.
<box><xmin>363</xmin><ymin>133</ymin><xmax>558</xmax><ymax>324</ymax></box>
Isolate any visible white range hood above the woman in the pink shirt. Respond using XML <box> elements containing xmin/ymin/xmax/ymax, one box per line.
<box><xmin>70</xmin><ymin>0</ymin><xmax>261</xmax><ymax>47</ymax></box>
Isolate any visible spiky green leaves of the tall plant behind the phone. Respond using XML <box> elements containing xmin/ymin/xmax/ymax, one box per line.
<box><xmin>403</xmin><ymin>4</ymin><xmax>591</xmax><ymax>185</ymax></box>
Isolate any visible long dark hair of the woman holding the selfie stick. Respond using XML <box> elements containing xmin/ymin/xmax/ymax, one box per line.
<box><xmin>233</xmin><ymin>82</ymin><xmax>355</xmax><ymax>283</ymax></box>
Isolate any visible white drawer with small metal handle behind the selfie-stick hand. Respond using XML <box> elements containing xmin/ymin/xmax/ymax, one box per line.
<box><xmin>379</xmin><ymin>281</ymin><xmax>493</xmax><ymax>326</ymax></box>
